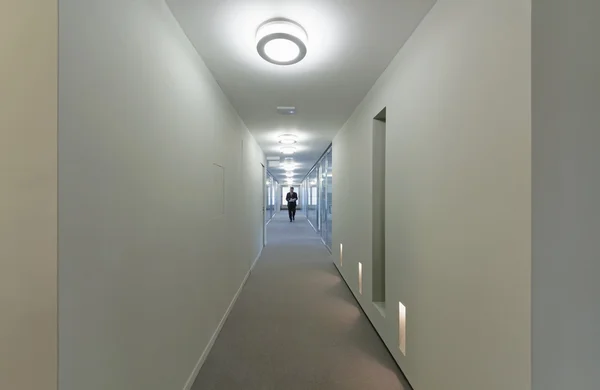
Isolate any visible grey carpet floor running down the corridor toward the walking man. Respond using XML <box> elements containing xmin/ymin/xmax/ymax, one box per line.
<box><xmin>192</xmin><ymin>212</ymin><xmax>410</xmax><ymax>390</ymax></box>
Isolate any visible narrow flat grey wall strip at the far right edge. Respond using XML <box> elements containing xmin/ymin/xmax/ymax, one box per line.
<box><xmin>532</xmin><ymin>0</ymin><xmax>600</xmax><ymax>390</ymax></box>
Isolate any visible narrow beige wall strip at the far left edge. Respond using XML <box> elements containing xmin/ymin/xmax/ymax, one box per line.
<box><xmin>0</xmin><ymin>0</ymin><xmax>57</xmax><ymax>390</ymax></box>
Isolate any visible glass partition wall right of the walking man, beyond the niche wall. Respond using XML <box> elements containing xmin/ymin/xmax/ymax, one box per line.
<box><xmin>301</xmin><ymin>146</ymin><xmax>333</xmax><ymax>250</ymax></box>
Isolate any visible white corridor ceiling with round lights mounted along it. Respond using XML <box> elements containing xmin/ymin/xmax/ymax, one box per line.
<box><xmin>167</xmin><ymin>0</ymin><xmax>436</xmax><ymax>184</ymax></box>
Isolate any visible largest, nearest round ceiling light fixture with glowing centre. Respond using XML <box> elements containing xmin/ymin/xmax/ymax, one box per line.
<box><xmin>256</xmin><ymin>19</ymin><xmax>308</xmax><ymax>65</ymax></box>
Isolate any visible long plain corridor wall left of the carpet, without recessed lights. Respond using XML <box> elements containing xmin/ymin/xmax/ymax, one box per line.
<box><xmin>59</xmin><ymin>0</ymin><xmax>264</xmax><ymax>390</ymax></box>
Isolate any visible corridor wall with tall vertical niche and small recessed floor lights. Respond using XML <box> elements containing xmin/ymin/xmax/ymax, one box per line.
<box><xmin>333</xmin><ymin>0</ymin><xmax>531</xmax><ymax>390</ymax></box>
